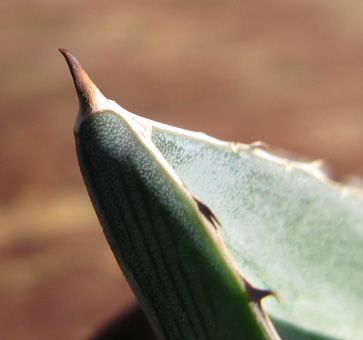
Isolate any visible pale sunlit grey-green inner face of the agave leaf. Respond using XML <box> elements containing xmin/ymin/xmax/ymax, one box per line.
<box><xmin>153</xmin><ymin>125</ymin><xmax>363</xmax><ymax>339</ymax></box>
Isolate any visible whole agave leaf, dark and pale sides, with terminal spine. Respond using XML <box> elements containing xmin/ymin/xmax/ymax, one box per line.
<box><xmin>60</xmin><ymin>49</ymin><xmax>363</xmax><ymax>340</ymax></box>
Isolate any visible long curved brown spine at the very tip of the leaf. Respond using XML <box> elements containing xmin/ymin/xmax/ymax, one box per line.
<box><xmin>59</xmin><ymin>48</ymin><xmax>106</xmax><ymax>115</ymax></box>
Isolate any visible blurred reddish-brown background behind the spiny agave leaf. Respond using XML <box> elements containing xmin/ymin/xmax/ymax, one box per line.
<box><xmin>0</xmin><ymin>0</ymin><xmax>363</xmax><ymax>340</ymax></box>
